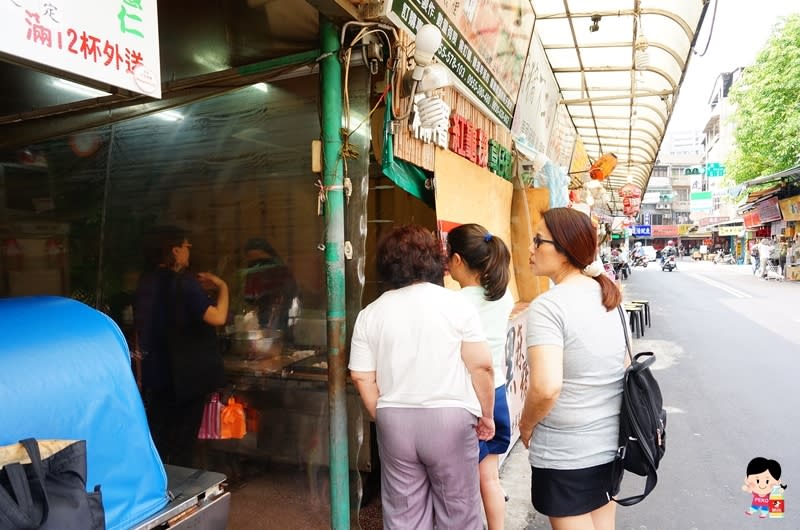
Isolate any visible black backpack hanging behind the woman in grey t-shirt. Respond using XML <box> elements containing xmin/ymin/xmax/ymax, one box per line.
<box><xmin>609</xmin><ymin>307</ymin><xmax>667</xmax><ymax>506</ymax></box>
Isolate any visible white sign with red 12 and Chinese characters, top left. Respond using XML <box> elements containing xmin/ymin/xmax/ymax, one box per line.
<box><xmin>0</xmin><ymin>0</ymin><xmax>161</xmax><ymax>98</ymax></box>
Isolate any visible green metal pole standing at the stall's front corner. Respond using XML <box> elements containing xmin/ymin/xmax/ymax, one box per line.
<box><xmin>319</xmin><ymin>15</ymin><xmax>350</xmax><ymax>530</ymax></box>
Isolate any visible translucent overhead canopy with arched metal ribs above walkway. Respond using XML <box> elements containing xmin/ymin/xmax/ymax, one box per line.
<box><xmin>532</xmin><ymin>0</ymin><xmax>708</xmax><ymax>204</ymax></box>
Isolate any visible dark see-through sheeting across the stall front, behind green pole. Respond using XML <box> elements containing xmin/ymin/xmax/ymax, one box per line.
<box><xmin>0</xmin><ymin>69</ymin><xmax>378</xmax><ymax>521</ymax></box>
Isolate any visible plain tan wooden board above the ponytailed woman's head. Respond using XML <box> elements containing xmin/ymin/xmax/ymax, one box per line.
<box><xmin>434</xmin><ymin>148</ymin><xmax>519</xmax><ymax>301</ymax></box>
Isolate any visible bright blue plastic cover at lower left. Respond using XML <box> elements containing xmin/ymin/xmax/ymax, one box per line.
<box><xmin>0</xmin><ymin>297</ymin><xmax>167</xmax><ymax>530</ymax></box>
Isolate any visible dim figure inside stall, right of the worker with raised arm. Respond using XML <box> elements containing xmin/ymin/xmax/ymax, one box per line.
<box><xmin>244</xmin><ymin>238</ymin><xmax>297</xmax><ymax>331</ymax></box>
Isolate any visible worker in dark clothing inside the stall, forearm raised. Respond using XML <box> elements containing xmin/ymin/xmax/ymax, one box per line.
<box><xmin>134</xmin><ymin>227</ymin><xmax>229</xmax><ymax>467</ymax></box>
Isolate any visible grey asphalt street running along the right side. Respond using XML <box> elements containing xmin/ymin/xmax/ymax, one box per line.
<box><xmin>503</xmin><ymin>258</ymin><xmax>800</xmax><ymax>530</ymax></box>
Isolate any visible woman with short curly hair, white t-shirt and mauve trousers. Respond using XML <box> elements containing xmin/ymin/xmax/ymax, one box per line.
<box><xmin>349</xmin><ymin>226</ymin><xmax>495</xmax><ymax>530</ymax></box>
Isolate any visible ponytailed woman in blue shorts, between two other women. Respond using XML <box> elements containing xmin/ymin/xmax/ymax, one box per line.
<box><xmin>447</xmin><ymin>223</ymin><xmax>514</xmax><ymax>530</ymax></box>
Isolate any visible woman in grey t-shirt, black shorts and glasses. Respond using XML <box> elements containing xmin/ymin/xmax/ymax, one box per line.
<box><xmin>520</xmin><ymin>208</ymin><xmax>625</xmax><ymax>530</ymax></box>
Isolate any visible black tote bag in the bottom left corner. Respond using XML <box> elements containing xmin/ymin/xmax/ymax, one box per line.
<box><xmin>0</xmin><ymin>438</ymin><xmax>105</xmax><ymax>530</ymax></box>
